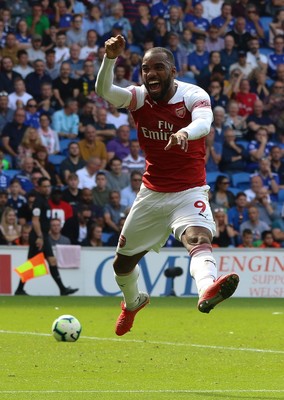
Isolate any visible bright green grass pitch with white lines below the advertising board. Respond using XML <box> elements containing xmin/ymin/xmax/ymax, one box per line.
<box><xmin>0</xmin><ymin>296</ymin><xmax>284</xmax><ymax>400</ymax></box>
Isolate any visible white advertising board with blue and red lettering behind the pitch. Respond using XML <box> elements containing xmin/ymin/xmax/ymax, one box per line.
<box><xmin>0</xmin><ymin>246</ymin><xmax>284</xmax><ymax>298</ymax></box>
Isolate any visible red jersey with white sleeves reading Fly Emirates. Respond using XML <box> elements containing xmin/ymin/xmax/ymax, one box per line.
<box><xmin>128</xmin><ymin>81</ymin><xmax>210</xmax><ymax>192</ymax></box>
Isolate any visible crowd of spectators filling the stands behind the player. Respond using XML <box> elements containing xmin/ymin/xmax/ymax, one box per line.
<box><xmin>0</xmin><ymin>0</ymin><xmax>284</xmax><ymax>247</ymax></box>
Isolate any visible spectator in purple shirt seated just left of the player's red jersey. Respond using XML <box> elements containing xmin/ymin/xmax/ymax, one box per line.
<box><xmin>107</xmin><ymin>125</ymin><xmax>130</xmax><ymax>160</ymax></box>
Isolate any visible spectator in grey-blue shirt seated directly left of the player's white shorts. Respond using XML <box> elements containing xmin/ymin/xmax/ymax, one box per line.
<box><xmin>104</xmin><ymin>190</ymin><xmax>127</xmax><ymax>233</ymax></box>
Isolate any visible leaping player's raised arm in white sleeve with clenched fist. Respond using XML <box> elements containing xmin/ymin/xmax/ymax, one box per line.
<box><xmin>96</xmin><ymin>35</ymin><xmax>131</xmax><ymax>107</ymax></box>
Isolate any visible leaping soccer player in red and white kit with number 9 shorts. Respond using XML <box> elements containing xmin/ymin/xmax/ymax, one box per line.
<box><xmin>96</xmin><ymin>35</ymin><xmax>239</xmax><ymax>336</ymax></box>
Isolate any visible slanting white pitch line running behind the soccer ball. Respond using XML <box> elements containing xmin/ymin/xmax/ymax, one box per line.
<box><xmin>0</xmin><ymin>330</ymin><xmax>284</xmax><ymax>354</ymax></box>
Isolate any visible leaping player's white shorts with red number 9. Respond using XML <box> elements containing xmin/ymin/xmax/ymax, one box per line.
<box><xmin>117</xmin><ymin>184</ymin><xmax>216</xmax><ymax>256</ymax></box>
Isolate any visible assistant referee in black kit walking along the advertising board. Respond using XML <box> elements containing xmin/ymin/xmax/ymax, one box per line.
<box><xmin>15</xmin><ymin>178</ymin><xmax>78</xmax><ymax>296</ymax></box>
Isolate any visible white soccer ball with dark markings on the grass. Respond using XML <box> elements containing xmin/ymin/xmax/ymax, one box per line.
<box><xmin>51</xmin><ymin>315</ymin><xmax>82</xmax><ymax>342</ymax></box>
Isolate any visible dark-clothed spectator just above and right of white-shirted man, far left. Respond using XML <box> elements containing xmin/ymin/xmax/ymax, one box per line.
<box><xmin>25</xmin><ymin>60</ymin><xmax>52</xmax><ymax>101</ymax></box>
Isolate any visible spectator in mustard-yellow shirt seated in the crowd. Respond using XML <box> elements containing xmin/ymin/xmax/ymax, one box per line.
<box><xmin>78</xmin><ymin>125</ymin><xmax>108</xmax><ymax>169</ymax></box>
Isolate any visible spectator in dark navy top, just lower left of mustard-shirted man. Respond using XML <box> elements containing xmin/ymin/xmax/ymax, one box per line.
<box><xmin>60</xmin><ymin>141</ymin><xmax>86</xmax><ymax>183</ymax></box>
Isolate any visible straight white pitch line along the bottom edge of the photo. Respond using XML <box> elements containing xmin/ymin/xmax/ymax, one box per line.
<box><xmin>0</xmin><ymin>389</ymin><xmax>284</xmax><ymax>394</ymax></box>
